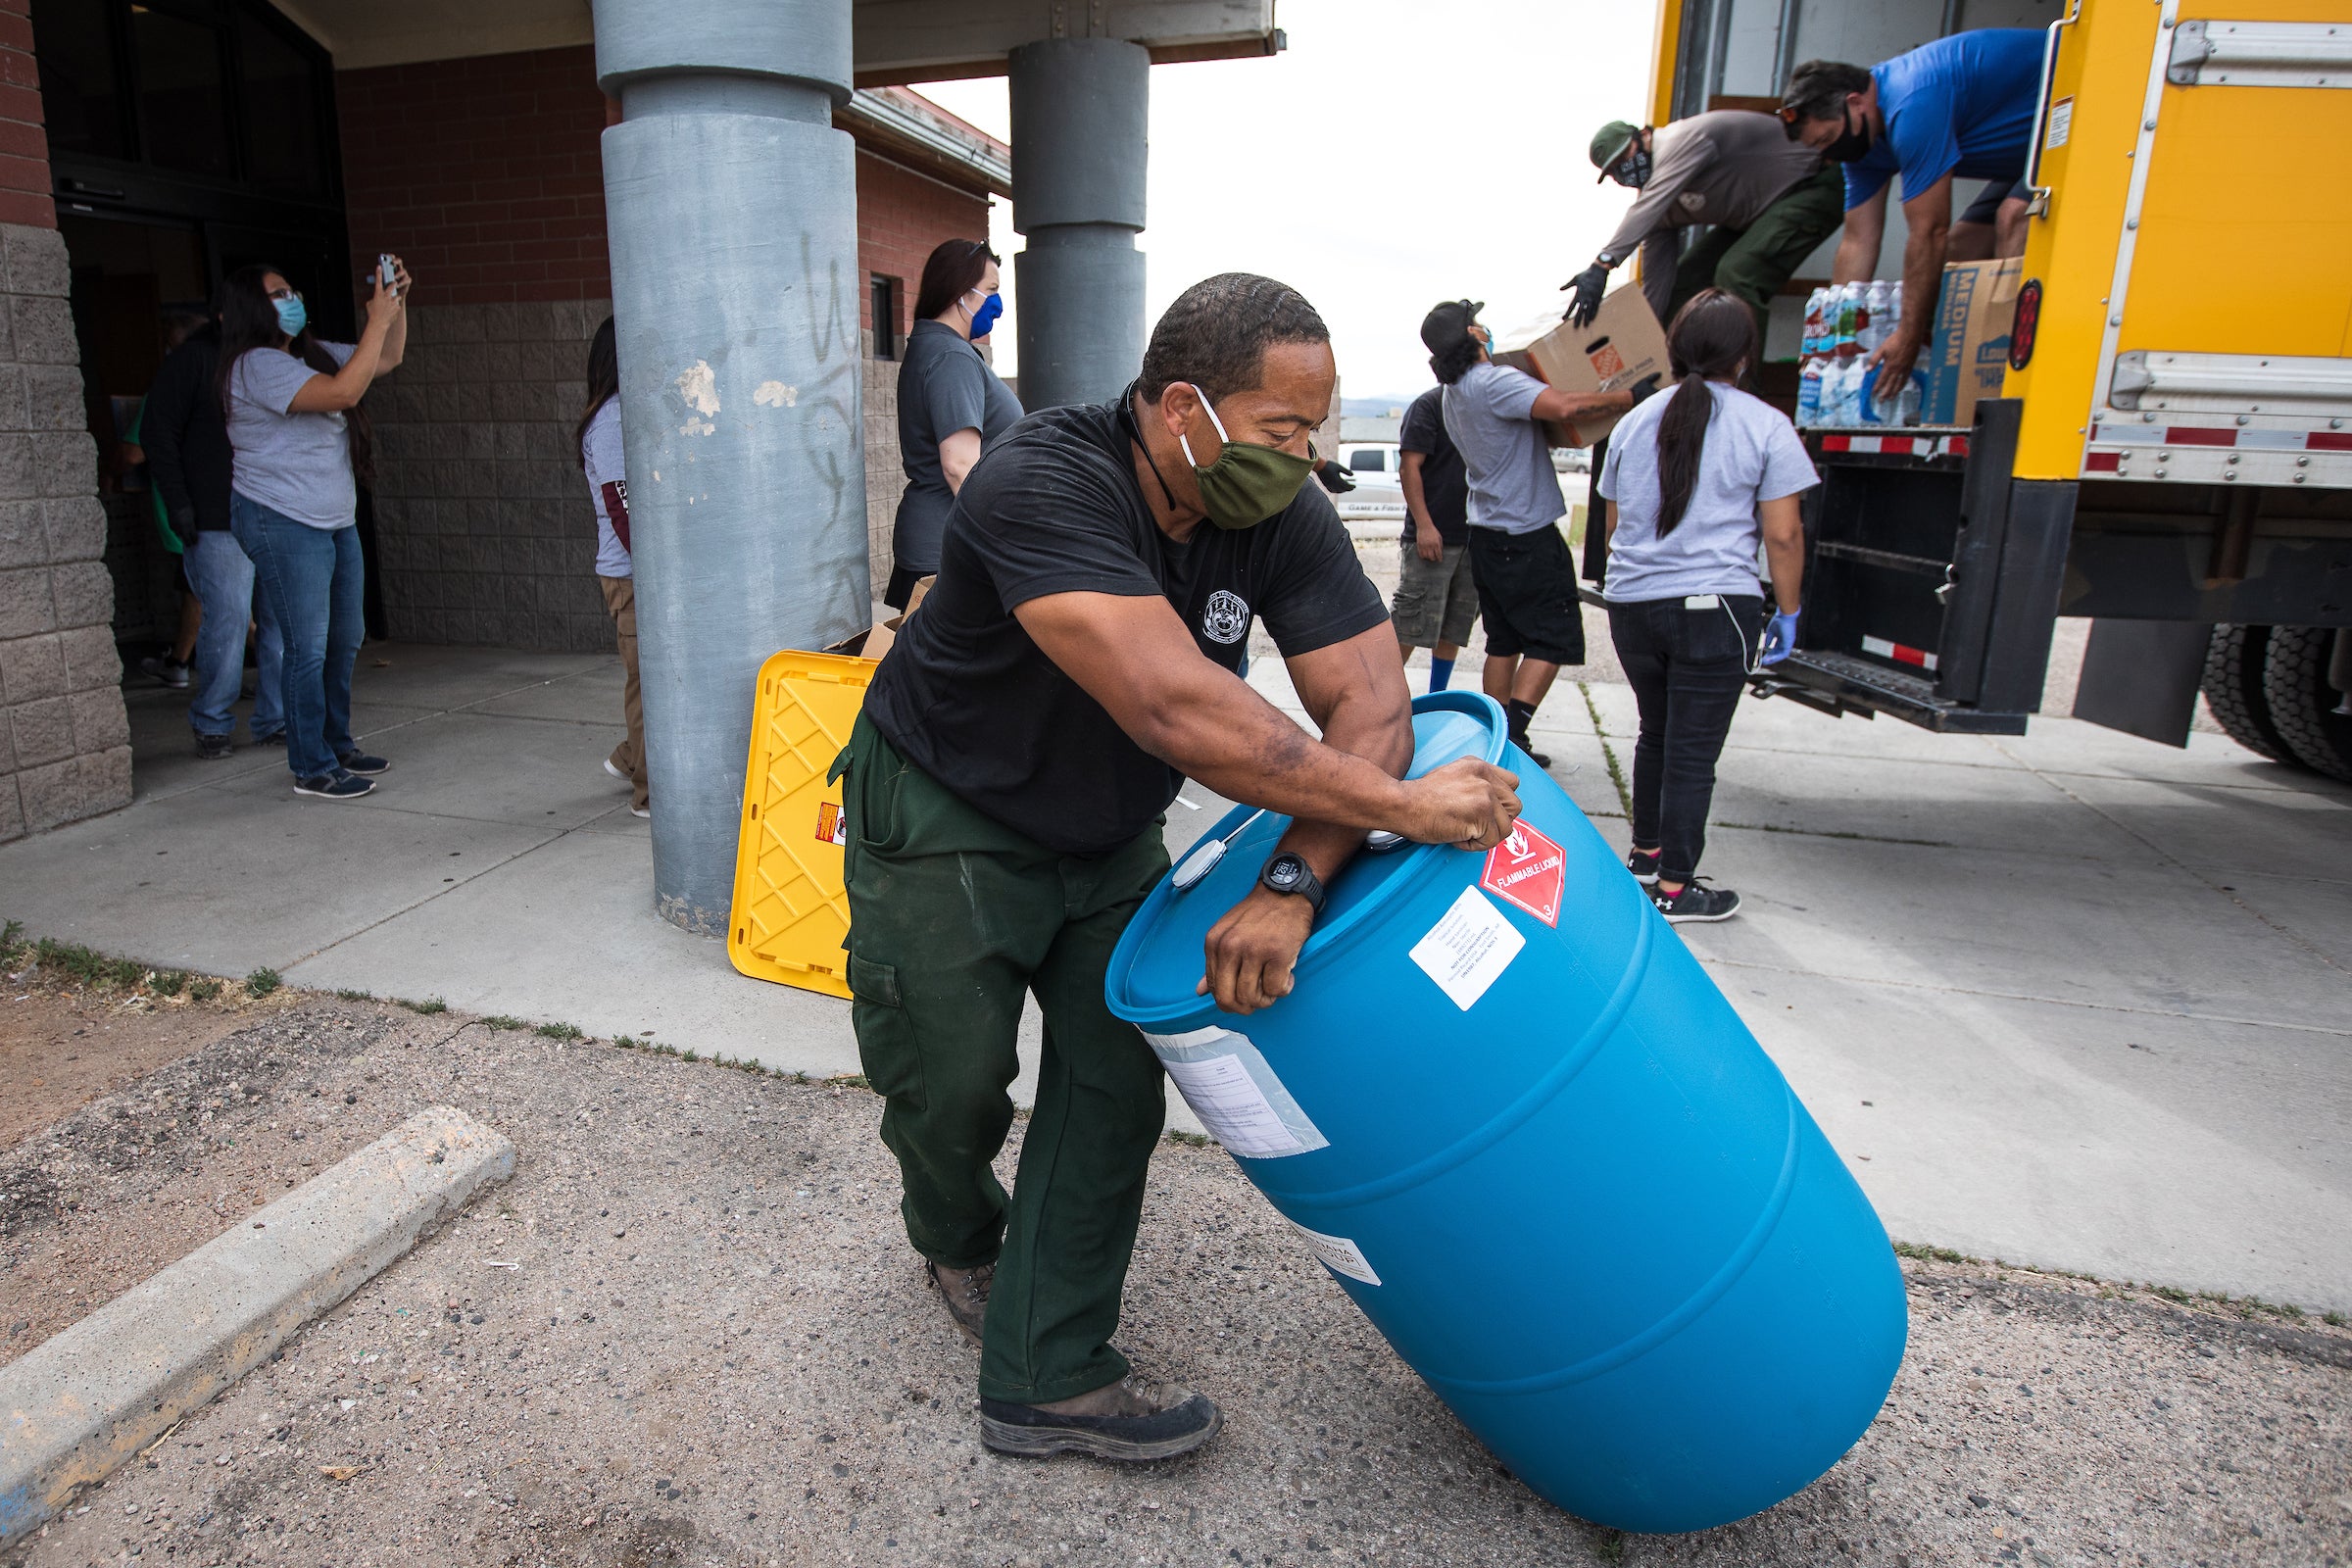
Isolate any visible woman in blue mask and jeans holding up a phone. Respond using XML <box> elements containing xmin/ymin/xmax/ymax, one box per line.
<box><xmin>219</xmin><ymin>256</ymin><xmax>410</xmax><ymax>800</ymax></box>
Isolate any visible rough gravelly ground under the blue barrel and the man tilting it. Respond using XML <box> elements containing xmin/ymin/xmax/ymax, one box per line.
<box><xmin>0</xmin><ymin>997</ymin><xmax>2352</xmax><ymax>1568</ymax></box>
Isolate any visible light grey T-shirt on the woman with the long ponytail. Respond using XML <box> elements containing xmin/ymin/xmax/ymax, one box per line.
<box><xmin>1599</xmin><ymin>381</ymin><xmax>1821</xmax><ymax>604</ymax></box>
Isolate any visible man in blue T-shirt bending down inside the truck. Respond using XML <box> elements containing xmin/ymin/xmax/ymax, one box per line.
<box><xmin>1781</xmin><ymin>28</ymin><xmax>2044</xmax><ymax>381</ymax></box>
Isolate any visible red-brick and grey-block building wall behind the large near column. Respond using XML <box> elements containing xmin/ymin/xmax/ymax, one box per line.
<box><xmin>336</xmin><ymin>52</ymin><xmax>988</xmax><ymax>654</ymax></box>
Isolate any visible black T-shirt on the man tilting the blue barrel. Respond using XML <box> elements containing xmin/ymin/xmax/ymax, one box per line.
<box><xmin>865</xmin><ymin>405</ymin><xmax>1388</xmax><ymax>856</ymax></box>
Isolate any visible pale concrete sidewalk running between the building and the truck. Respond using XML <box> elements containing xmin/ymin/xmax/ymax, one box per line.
<box><xmin>0</xmin><ymin>629</ymin><xmax>2352</xmax><ymax>1309</ymax></box>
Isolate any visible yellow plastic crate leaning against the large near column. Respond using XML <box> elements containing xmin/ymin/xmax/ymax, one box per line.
<box><xmin>727</xmin><ymin>649</ymin><xmax>877</xmax><ymax>997</ymax></box>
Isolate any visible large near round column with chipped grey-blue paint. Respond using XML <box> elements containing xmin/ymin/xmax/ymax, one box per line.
<box><xmin>595</xmin><ymin>0</ymin><xmax>870</xmax><ymax>936</ymax></box>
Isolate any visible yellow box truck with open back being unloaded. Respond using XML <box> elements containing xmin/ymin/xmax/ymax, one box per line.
<box><xmin>1651</xmin><ymin>0</ymin><xmax>2352</xmax><ymax>780</ymax></box>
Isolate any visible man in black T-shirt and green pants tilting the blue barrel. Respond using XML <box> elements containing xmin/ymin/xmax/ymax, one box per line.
<box><xmin>835</xmin><ymin>272</ymin><xmax>1519</xmax><ymax>1460</ymax></box>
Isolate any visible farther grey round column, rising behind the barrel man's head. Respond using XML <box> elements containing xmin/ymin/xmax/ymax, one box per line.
<box><xmin>1011</xmin><ymin>37</ymin><xmax>1152</xmax><ymax>409</ymax></box>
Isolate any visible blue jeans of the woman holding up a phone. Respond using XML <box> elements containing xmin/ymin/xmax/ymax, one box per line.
<box><xmin>228</xmin><ymin>491</ymin><xmax>367</xmax><ymax>778</ymax></box>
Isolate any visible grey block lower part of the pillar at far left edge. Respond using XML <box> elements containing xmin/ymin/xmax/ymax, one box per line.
<box><xmin>0</xmin><ymin>220</ymin><xmax>131</xmax><ymax>842</ymax></box>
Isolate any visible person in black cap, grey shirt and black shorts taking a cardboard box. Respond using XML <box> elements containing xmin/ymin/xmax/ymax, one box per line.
<box><xmin>1421</xmin><ymin>299</ymin><xmax>1658</xmax><ymax>766</ymax></box>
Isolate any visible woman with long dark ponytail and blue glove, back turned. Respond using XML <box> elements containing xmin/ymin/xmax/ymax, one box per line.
<box><xmin>1599</xmin><ymin>289</ymin><xmax>1821</xmax><ymax>924</ymax></box>
